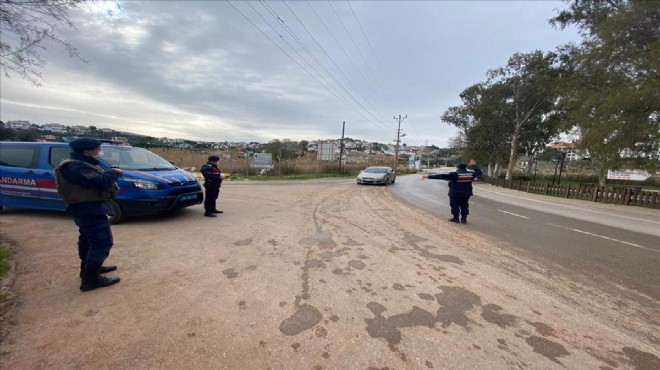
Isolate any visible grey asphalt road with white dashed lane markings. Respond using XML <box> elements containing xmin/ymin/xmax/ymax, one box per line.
<box><xmin>390</xmin><ymin>175</ymin><xmax>660</xmax><ymax>304</ymax></box>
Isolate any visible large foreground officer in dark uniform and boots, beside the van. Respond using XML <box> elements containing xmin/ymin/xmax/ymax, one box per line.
<box><xmin>55</xmin><ymin>138</ymin><xmax>122</xmax><ymax>291</ymax></box>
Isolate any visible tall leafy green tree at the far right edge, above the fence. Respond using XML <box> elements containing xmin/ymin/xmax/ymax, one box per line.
<box><xmin>551</xmin><ymin>0</ymin><xmax>660</xmax><ymax>185</ymax></box>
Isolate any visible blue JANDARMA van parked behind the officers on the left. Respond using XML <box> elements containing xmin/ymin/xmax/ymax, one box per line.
<box><xmin>0</xmin><ymin>142</ymin><xmax>203</xmax><ymax>223</ymax></box>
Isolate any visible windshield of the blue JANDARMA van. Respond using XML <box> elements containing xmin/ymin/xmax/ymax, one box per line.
<box><xmin>102</xmin><ymin>145</ymin><xmax>176</xmax><ymax>171</ymax></box>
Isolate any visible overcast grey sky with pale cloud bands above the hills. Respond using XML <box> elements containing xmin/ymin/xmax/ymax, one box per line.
<box><xmin>0</xmin><ymin>1</ymin><xmax>579</xmax><ymax>147</ymax></box>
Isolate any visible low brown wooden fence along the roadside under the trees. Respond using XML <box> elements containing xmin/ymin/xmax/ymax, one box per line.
<box><xmin>482</xmin><ymin>176</ymin><xmax>660</xmax><ymax>209</ymax></box>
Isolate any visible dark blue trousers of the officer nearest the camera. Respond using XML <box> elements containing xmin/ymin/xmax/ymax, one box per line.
<box><xmin>73</xmin><ymin>216</ymin><xmax>113</xmax><ymax>271</ymax></box>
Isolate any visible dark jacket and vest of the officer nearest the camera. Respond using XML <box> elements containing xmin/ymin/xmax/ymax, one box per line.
<box><xmin>55</xmin><ymin>152</ymin><xmax>117</xmax><ymax>216</ymax></box>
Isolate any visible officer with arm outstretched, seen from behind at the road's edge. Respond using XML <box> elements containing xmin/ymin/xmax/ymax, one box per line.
<box><xmin>422</xmin><ymin>160</ymin><xmax>482</xmax><ymax>224</ymax></box>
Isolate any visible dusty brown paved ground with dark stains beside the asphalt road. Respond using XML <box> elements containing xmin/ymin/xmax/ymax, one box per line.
<box><xmin>0</xmin><ymin>180</ymin><xmax>660</xmax><ymax>369</ymax></box>
